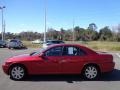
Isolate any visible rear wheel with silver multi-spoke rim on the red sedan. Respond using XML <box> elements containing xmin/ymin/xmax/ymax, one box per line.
<box><xmin>82</xmin><ymin>65</ymin><xmax>100</xmax><ymax>80</ymax></box>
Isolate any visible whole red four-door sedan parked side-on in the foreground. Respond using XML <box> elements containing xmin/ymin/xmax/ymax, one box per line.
<box><xmin>2</xmin><ymin>44</ymin><xmax>115</xmax><ymax>80</ymax></box>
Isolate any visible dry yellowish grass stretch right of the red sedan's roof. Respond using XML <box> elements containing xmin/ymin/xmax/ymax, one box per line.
<box><xmin>67</xmin><ymin>41</ymin><xmax>120</xmax><ymax>51</ymax></box>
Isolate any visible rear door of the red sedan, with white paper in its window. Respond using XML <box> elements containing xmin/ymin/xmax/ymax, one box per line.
<box><xmin>60</xmin><ymin>46</ymin><xmax>86</xmax><ymax>74</ymax></box>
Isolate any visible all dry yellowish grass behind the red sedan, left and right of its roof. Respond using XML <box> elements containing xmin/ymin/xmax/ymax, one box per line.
<box><xmin>23</xmin><ymin>41</ymin><xmax>120</xmax><ymax>51</ymax></box>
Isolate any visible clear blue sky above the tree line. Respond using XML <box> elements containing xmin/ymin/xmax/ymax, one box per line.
<box><xmin>0</xmin><ymin>0</ymin><xmax>120</xmax><ymax>33</ymax></box>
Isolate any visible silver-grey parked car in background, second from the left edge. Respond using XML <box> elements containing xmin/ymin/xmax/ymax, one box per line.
<box><xmin>7</xmin><ymin>39</ymin><xmax>25</xmax><ymax>49</ymax></box>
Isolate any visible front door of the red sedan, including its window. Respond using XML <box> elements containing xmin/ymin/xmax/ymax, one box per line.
<box><xmin>39</xmin><ymin>46</ymin><xmax>62</xmax><ymax>74</ymax></box>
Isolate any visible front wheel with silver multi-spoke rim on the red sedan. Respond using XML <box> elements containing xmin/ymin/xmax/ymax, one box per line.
<box><xmin>9</xmin><ymin>65</ymin><xmax>27</xmax><ymax>81</ymax></box>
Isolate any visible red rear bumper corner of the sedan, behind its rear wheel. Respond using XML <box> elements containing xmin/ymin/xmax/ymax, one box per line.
<box><xmin>101</xmin><ymin>62</ymin><xmax>115</xmax><ymax>73</ymax></box>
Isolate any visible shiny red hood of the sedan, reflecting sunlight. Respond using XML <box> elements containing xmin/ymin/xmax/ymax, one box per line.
<box><xmin>7</xmin><ymin>54</ymin><xmax>42</xmax><ymax>62</ymax></box>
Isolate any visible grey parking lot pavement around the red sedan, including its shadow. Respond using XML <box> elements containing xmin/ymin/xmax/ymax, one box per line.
<box><xmin>0</xmin><ymin>48</ymin><xmax>120</xmax><ymax>90</ymax></box>
